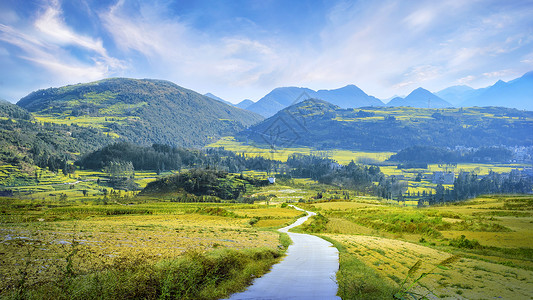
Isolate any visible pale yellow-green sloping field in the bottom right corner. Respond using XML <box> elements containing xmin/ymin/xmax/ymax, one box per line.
<box><xmin>325</xmin><ymin>234</ymin><xmax>533</xmax><ymax>299</ymax></box>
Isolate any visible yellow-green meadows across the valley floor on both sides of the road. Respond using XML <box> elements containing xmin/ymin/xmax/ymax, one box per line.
<box><xmin>0</xmin><ymin>156</ymin><xmax>533</xmax><ymax>299</ymax></box>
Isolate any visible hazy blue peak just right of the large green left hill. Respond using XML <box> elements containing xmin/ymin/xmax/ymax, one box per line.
<box><xmin>247</xmin><ymin>87</ymin><xmax>316</xmax><ymax>117</ymax></box>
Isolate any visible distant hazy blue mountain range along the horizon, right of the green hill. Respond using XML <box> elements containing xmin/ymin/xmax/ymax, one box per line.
<box><xmin>201</xmin><ymin>71</ymin><xmax>533</xmax><ymax>117</ymax></box>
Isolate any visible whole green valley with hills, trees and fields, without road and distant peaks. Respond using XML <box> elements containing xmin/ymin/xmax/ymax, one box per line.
<box><xmin>0</xmin><ymin>79</ymin><xmax>533</xmax><ymax>299</ymax></box>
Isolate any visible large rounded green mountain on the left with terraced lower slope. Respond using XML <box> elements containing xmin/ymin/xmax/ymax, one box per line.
<box><xmin>17</xmin><ymin>78</ymin><xmax>262</xmax><ymax>147</ymax></box>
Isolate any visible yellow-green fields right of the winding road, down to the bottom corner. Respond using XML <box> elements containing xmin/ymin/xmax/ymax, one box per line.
<box><xmin>301</xmin><ymin>195</ymin><xmax>533</xmax><ymax>299</ymax></box>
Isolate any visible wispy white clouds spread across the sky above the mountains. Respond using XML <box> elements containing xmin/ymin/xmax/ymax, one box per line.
<box><xmin>0</xmin><ymin>0</ymin><xmax>533</xmax><ymax>101</ymax></box>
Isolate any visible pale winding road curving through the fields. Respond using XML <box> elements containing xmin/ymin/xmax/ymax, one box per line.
<box><xmin>229</xmin><ymin>207</ymin><xmax>340</xmax><ymax>300</ymax></box>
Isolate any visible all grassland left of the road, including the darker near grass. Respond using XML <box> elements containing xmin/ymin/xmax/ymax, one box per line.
<box><xmin>0</xmin><ymin>183</ymin><xmax>301</xmax><ymax>299</ymax></box>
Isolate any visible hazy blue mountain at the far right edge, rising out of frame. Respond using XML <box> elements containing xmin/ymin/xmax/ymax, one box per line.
<box><xmin>461</xmin><ymin>71</ymin><xmax>533</xmax><ymax>110</ymax></box>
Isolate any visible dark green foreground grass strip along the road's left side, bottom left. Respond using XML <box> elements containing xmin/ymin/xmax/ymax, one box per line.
<box><xmin>2</xmin><ymin>248</ymin><xmax>281</xmax><ymax>299</ymax></box>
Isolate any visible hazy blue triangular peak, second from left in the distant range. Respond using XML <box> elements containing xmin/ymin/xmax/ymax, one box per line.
<box><xmin>316</xmin><ymin>84</ymin><xmax>384</xmax><ymax>108</ymax></box>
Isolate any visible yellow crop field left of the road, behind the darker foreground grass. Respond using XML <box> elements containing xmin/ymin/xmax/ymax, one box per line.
<box><xmin>0</xmin><ymin>195</ymin><xmax>301</xmax><ymax>291</ymax></box>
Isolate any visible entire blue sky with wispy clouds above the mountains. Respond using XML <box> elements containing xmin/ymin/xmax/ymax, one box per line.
<box><xmin>0</xmin><ymin>0</ymin><xmax>533</xmax><ymax>103</ymax></box>
